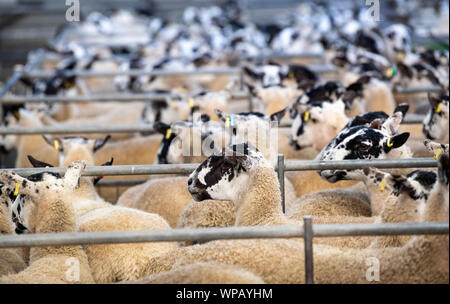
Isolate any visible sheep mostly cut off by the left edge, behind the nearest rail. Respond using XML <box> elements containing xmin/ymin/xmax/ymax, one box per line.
<box><xmin>0</xmin><ymin>183</ymin><xmax>26</xmax><ymax>277</ymax></box>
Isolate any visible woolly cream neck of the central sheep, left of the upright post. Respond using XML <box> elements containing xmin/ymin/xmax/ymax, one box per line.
<box><xmin>235</xmin><ymin>167</ymin><xmax>284</xmax><ymax>226</ymax></box>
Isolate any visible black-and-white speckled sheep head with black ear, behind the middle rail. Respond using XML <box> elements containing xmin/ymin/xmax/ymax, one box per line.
<box><xmin>316</xmin><ymin>125</ymin><xmax>409</xmax><ymax>182</ymax></box>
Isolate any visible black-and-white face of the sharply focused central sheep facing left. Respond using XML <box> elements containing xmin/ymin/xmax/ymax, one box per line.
<box><xmin>188</xmin><ymin>143</ymin><xmax>271</xmax><ymax>202</ymax></box>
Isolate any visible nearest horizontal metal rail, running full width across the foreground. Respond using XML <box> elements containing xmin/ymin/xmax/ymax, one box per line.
<box><xmin>0</xmin><ymin>223</ymin><xmax>449</xmax><ymax>248</ymax></box>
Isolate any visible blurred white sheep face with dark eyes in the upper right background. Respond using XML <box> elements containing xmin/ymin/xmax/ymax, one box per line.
<box><xmin>383</xmin><ymin>24</ymin><xmax>411</xmax><ymax>62</ymax></box>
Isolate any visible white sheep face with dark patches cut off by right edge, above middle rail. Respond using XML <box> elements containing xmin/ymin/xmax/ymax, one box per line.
<box><xmin>422</xmin><ymin>95</ymin><xmax>449</xmax><ymax>143</ymax></box>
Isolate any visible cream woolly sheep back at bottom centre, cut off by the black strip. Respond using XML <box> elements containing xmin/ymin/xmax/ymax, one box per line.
<box><xmin>121</xmin><ymin>263</ymin><xmax>264</xmax><ymax>284</ymax></box>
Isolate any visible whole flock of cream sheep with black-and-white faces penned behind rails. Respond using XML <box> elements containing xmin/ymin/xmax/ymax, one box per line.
<box><xmin>0</xmin><ymin>4</ymin><xmax>449</xmax><ymax>283</ymax></box>
